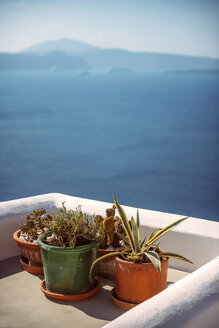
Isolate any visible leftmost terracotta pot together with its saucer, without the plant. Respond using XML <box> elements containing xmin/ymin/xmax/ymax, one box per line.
<box><xmin>13</xmin><ymin>230</ymin><xmax>43</xmax><ymax>274</ymax></box>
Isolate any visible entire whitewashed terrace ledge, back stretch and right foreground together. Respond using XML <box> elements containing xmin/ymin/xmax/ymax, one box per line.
<box><xmin>0</xmin><ymin>193</ymin><xmax>219</xmax><ymax>328</ymax></box>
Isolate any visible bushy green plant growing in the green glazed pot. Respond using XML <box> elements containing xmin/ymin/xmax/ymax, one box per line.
<box><xmin>44</xmin><ymin>202</ymin><xmax>100</xmax><ymax>247</ymax></box>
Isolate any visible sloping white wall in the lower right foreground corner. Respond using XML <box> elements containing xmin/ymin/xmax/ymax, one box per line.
<box><xmin>104</xmin><ymin>257</ymin><xmax>219</xmax><ymax>328</ymax></box>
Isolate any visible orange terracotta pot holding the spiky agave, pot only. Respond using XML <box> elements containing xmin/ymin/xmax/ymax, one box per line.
<box><xmin>115</xmin><ymin>257</ymin><xmax>168</xmax><ymax>304</ymax></box>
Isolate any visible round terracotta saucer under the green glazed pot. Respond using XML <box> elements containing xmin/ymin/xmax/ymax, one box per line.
<box><xmin>40</xmin><ymin>278</ymin><xmax>100</xmax><ymax>301</ymax></box>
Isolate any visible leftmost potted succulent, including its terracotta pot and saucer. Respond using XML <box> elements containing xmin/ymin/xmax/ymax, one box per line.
<box><xmin>13</xmin><ymin>208</ymin><xmax>52</xmax><ymax>274</ymax></box>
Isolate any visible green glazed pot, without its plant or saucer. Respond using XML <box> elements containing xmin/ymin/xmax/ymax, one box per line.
<box><xmin>37</xmin><ymin>232</ymin><xmax>98</xmax><ymax>295</ymax></box>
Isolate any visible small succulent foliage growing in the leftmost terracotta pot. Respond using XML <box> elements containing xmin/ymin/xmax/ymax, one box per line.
<box><xmin>20</xmin><ymin>208</ymin><xmax>52</xmax><ymax>242</ymax></box>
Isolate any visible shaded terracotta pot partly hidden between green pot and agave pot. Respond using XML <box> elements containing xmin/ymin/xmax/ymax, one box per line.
<box><xmin>97</xmin><ymin>248</ymin><xmax>124</xmax><ymax>279</ymax></box>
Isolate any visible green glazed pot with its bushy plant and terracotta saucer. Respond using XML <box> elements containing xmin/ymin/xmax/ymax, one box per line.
<box><xmin>38</xmin><ymin>203</ymin><xmax>100</xmax><ymax>300</ymax></box>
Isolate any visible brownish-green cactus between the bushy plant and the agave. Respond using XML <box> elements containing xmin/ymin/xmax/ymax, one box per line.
<box><xmin>95</xmin><ymin>205</ymin><xmax>125</xmax><ymax>249</ymax></box>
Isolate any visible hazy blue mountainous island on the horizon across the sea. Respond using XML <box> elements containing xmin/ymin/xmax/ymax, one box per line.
<box><xmin>0</xmin><ymin>39</ymin><xmax>219</xmax><ymax>72</ymax></box>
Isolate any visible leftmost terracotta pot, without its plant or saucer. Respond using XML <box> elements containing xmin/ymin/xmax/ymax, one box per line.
<box><xmin>13</xmin><ymin>230</ymin><xmax>42</xmax><ymax>265</ymax></box>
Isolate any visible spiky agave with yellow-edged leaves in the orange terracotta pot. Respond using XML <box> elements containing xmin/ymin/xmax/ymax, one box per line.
<box><xmin>90</xmin><ymin>195</ymin><xmax>192</xmax><ymax>279</ymax></box>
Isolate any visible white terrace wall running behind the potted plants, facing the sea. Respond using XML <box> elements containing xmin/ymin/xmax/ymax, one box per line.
<box><xmin>0</xmin><ymin>194</ymin><xmax>219</xmax><ymax>272</ymax></box>
